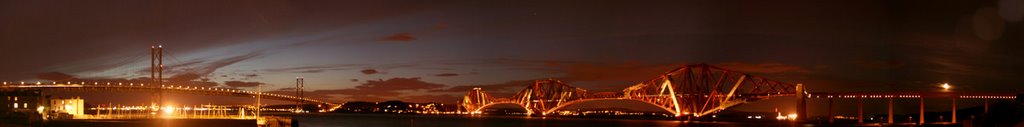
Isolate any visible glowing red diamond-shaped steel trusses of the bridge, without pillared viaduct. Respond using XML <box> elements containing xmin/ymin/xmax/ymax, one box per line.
<box><xmin>460</xmin><ymin>64</ymin><xmax>803</xmax><ymax>117</ymax></box>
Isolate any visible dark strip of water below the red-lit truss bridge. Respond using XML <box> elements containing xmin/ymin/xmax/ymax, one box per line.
<box><xmin>278</xmin><ymin>114</ymin><xmax>799</xmax><ymax>127</ymax></box>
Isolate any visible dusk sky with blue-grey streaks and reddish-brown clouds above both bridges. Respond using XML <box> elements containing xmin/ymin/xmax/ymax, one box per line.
<box><xmin>0</xmin><ymin>0</ymin><xmax>1024</xmax><ymax>114</ymax></box>
